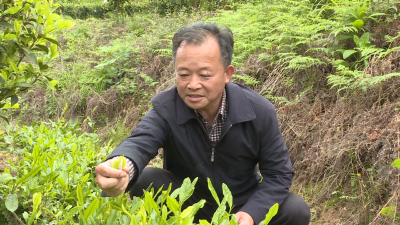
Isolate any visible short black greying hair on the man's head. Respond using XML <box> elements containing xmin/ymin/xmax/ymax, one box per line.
<box><xmin>172</xmin><ymin>22</ymin><xmax>234</xmax><ymax>68</ymax></box>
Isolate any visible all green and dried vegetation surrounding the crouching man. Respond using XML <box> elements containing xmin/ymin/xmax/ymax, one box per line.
<box><xmin>0</xmin><ymin>0</ymin><xmax>400</xmax><ymax>224</ymax></box>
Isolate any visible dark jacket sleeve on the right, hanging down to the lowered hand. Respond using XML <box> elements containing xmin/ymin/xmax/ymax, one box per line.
<box><xmin>240</xmin><ymin>103</ymin><xmax>293</xmax><ymax>224</ymax></box>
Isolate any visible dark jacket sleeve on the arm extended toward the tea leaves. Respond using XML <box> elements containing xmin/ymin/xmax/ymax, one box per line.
<box><xmin>107</xmin><ymin>109</ymin><xmax>168</xmax><ymax>190</ymax></box>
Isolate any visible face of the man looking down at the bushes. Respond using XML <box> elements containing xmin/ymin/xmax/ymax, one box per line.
<box><xmin>175</xmin><ymin>37</ymin><xmax>234</xmax><ymax>119</ymax></box>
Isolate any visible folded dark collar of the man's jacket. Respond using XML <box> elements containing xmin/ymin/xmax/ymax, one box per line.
<box><xmin>176</xmin><ymin>82</ymin><xmax>256</xmax><ymax>125</ymax></box>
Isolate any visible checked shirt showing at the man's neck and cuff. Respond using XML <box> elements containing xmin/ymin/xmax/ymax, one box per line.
<box><xmin>117</xmin><ymin>89</ymin><xmax>228</xmax><ymax>181</ymax></box>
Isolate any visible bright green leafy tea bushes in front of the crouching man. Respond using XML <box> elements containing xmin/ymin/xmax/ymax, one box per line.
<box><xmin>0</xmin><ymin>112</ymin><xmax>278</xmax><ymax>225</ymax></box>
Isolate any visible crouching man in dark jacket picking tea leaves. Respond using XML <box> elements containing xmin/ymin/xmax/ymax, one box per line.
<box><xmin>96</xmin><ymin>23</ymin><xmax>310</xmax><ymax>225</ymax></box>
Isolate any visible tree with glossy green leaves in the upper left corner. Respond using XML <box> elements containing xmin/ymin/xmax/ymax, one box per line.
<box><xmin>0</xmin><ymin>0</ymin><xmax>74</xmax><ymax>121</ymax></box>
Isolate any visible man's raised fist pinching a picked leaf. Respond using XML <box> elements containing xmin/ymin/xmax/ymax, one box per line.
<box><xmin>96</xmin><ymin>159</ymin><xmax>129</xmax><ymax>197</ymax></box>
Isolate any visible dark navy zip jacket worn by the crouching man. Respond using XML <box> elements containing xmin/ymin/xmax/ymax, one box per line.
<box><xmin>109</xmin><ymin>82</ymin><xmax>293</xmax><ymax>224</ymax></box>
